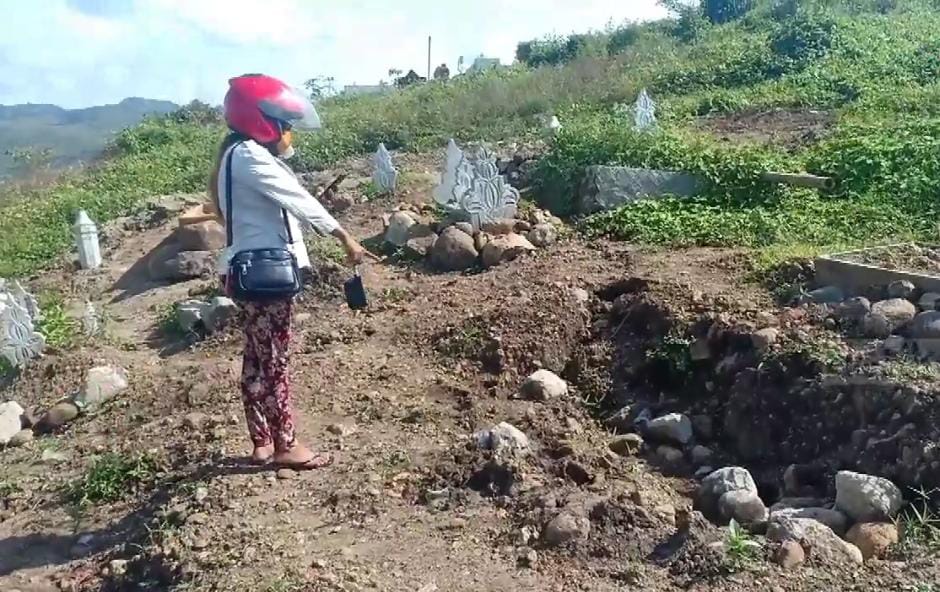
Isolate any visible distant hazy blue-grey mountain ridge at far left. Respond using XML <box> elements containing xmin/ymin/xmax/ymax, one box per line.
<box><xmin>0</xmin><ymin>98</ymin><xmax>178</xmax><ymax>179</ymax></box>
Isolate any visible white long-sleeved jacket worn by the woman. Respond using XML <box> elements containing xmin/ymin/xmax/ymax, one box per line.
<box><xmin>218</xmin><ymin>140</ymin><xmax>339</xmax><ymax>273</ymax></box>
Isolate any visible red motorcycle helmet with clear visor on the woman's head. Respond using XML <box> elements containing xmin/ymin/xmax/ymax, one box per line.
<box><xmin>224</xmin><ymin>74</ymin><xmax>320</xmax><ymax>144</ymax></box>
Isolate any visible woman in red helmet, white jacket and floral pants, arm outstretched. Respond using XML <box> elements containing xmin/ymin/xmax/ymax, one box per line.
<box><xmin>210</xmin><ymin>74</ymin><xmax>375</xmax><ymax>469</ymax></box>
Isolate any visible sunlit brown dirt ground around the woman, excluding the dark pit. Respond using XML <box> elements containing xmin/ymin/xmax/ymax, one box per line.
<box><xmin>0</xmin><ymin>158</ymin><xmax>937</xmax><ymax>592</ymax></box>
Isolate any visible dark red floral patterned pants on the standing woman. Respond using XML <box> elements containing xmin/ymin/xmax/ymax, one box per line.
<box><xmin>241</xmin><ymin>300</ymin><xmax>295</xmax><ymax>451</ymax></box>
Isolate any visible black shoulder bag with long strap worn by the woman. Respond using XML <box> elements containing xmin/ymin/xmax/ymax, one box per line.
<box><xmin>225</xmin><ymin>144</ymin><xmax>301</xmax><ymax>302</ymax></box>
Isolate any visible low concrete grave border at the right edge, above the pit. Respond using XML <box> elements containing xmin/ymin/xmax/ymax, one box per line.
<box><xmin>816</xmin><ymin>243</ymin><xmax>940</xmax><ymax>294</ymax></box>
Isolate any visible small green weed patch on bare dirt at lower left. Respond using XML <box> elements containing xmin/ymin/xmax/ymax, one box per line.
<box><xmin>66</xmin><ymin>453</ymin><xmax>157</xmax><ymax>506</ymax></box>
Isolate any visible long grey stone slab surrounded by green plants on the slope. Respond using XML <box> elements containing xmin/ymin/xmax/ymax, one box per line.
<box><xmin>578</xmin><ymin>166</ymin><xmax>702</xmax><ymax>214</ymax></box>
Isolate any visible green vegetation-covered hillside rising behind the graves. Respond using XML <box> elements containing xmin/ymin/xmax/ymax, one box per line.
<box><xmin>0</xmin><ymin>0</ymin><xmax>940</xmax><ymax>275</ymax></box>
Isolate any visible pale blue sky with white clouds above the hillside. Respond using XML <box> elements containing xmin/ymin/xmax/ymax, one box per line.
<box><xmin>0</xmin><ymin>0</ymin><xmax>664</xmax><ymax>108</ymax></box>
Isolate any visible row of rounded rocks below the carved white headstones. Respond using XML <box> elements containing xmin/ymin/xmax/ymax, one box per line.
<box><xmin>383</xmin><ymin>204</ymin><xmax>561</xmax><ymax>271</ymax></box>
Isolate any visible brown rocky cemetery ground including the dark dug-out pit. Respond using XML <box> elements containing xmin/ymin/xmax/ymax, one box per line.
<box><xmin>0</xmin><ymin>148</ymin><xmax>940</xmax><ymax>592</ymax></box>
